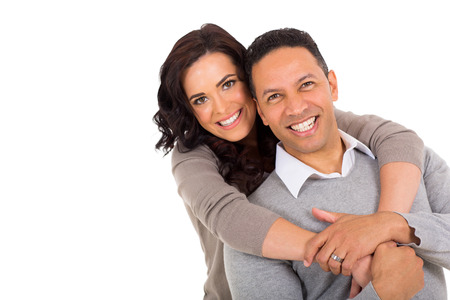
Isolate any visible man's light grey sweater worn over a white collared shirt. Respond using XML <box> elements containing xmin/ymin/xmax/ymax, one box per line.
<box><xmin>224</xmin><ymin>151</ymin><xmax>450</xmax><ymax>300</ymax></box>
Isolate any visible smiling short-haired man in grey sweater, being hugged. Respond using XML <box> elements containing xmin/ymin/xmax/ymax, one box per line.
<box><xmin>225</xmin><ymin>29</ymin><xmax>450</xmax><ymax>299</ymax></box>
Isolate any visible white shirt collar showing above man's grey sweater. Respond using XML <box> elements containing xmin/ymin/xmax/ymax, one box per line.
<box><xmin>275</xmin><ymin>130</ymin><xmax>375</xmax><ymax>198</ymax></box>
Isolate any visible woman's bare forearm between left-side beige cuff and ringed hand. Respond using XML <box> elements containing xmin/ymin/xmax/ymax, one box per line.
<box><xmin>262</xmin><ymin>218</ymin><xmax>315</xmax><ymax>261</ymax></box>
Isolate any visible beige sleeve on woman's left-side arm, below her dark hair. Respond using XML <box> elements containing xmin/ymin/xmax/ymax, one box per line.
<box><xmin>172</xmin><ymin>145</ymin><xmax>279</xmax><ymax>256</ymax></box>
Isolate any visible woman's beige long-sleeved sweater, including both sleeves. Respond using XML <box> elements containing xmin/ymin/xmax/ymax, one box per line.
<box><xmin>172</xmin><ymin>110</ymin><xmax>423</xmax><ymax>299</ymax></box>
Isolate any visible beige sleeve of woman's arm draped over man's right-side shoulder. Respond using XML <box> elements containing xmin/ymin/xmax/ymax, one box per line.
<box><xmin>335</xmin><ymin>109</ymin><xmax>424</xmax><ymax>170</ymax></box>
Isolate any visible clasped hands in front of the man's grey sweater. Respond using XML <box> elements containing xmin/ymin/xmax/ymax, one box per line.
<box><xmin>304</xmin><ymin>208</ymin><xmax>423</xmax><ymax>298</ymax></box>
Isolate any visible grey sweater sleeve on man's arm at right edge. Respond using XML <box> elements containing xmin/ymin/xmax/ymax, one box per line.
<box><xmin>401</xmin><ymin>148</ymin><xmax>450</xmax><ymax>269</ymax></box>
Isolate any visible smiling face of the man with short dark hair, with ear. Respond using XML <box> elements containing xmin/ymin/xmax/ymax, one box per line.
<box><xmin>252</xmin><ymin>47</ymin><xmax>339</xmax><ymax>160</ymax></box>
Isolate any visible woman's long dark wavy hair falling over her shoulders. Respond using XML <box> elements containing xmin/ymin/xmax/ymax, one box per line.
<box><xmin>153</xmin><ymin>24</ymin><xmax>276</xmax><ymax>194</ymax></box>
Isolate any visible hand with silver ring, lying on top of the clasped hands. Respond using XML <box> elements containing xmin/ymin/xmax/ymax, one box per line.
<box><xmin>304</xmin><ymin>208</ymin><xmax>409</xmax><ymax>276</ymax></box>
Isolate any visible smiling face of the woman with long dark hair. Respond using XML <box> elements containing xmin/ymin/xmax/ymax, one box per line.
<box><xmin>182</xmin><ymin>52</ymin><xmax>256</xmax><ymax>142</ymax></box>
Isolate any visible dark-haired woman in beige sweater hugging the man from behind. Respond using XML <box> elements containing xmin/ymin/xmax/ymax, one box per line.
<box><xmin>154</xmin><ymin>24</ymin><xmax>423</xmax><ymax>299</ymax></box>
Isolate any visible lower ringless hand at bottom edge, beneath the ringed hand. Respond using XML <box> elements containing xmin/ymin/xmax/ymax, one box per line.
<box><xmin>371</xmin><ymin>242</ymin><xmax>424</xmax><ymax>300</ymax></box>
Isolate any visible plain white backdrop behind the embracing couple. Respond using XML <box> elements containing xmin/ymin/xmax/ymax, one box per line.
<box><xmin>0</xmin><ymin>0</ymin><xmax>450</xmax><ymax>300</ymax></box>
